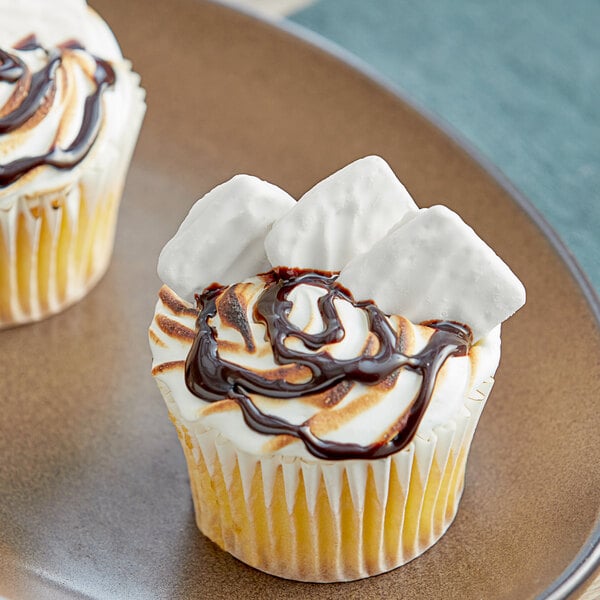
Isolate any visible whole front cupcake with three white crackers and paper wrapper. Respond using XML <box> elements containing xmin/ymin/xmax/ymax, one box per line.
<box><xmin>149</xmin><ymin>156</ymin><xmax>525</xmax><ymax>582</ymax></box>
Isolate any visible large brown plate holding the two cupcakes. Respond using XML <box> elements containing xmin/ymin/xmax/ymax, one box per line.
<box><xmin>0</xmin><ymin>0</ymin><xmax>600</xmax><ymax>600</ymax></box>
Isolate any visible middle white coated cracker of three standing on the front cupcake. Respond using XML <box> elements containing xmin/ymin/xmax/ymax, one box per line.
<box><xmin>265</xmin><ymin>156</ymin><xmax>417</xmax><ymax>271</ymax></box>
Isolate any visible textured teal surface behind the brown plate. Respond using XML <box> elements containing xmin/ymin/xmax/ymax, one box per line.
<box><xmin>291</xmin><ymin>0</ymin><xmax>600</xmax><ymax>291</ymax></box>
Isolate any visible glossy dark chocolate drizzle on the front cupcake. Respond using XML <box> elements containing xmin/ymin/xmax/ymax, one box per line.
<box><xmin>185</xmin><ymin>269</ymin><xmax>472</xmax><ymax>460</ymax></box>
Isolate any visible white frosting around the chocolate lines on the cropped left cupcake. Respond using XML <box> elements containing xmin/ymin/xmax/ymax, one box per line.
<box><xmin>0</xmin><ymin>0</ymin><xmax>143</xmax><ymax>202</ymax></box>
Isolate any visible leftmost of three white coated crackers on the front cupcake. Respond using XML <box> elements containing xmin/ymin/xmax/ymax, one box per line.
<box><xmin>158</xmin><ymin>175</ymin><xmax>295</xmax><ymax>302</ymax></box>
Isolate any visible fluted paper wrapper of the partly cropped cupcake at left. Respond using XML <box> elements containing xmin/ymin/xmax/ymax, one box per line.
<box><xmin>0</xmin><ymin>81</ymin><xmax>146</xmax><ymax>329</ymax></box>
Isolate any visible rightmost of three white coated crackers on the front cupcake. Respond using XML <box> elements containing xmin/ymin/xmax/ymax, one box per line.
<box><xmin>338</xmin><ymin>206</ymin><xmax>525</xmax><ymax>341</ymax></box>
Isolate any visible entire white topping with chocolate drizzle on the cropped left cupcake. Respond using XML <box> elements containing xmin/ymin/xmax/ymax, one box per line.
<box><xmin>0</xmin><ymin>0</ymin><xmax>142</xmax><ymax>202</ymax></box>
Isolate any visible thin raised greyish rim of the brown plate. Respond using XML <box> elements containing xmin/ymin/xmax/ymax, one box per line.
<box><xmin>203</xmin><ymin>0</ymin><xmax>600</xmax><ymax>600</ymax></box>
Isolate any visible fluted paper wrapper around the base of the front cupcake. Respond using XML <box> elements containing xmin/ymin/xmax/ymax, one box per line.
<box><xmin>159</xmin><ymin>379</ymin><xmax>493</xmax><ymax>582</ymax></box>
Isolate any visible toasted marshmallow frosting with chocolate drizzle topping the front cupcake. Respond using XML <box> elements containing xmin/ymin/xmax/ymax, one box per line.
<box><xmin>150</xmin><ymin>272</ymin><xmax>500</xmax><ymax>459</ymax></box>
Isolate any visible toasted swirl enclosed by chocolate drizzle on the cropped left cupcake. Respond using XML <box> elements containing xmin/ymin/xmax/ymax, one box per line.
<box><xmin>0</xmin><ymin>35</ymin><xmax>115</xmax><ymax>188</ymax></box>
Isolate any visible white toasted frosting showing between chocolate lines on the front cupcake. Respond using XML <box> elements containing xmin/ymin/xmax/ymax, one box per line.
<box><xmin>150</xmin><ymin>278</ymin><xmax>500</xmax><ymax>458</ymax></box>
